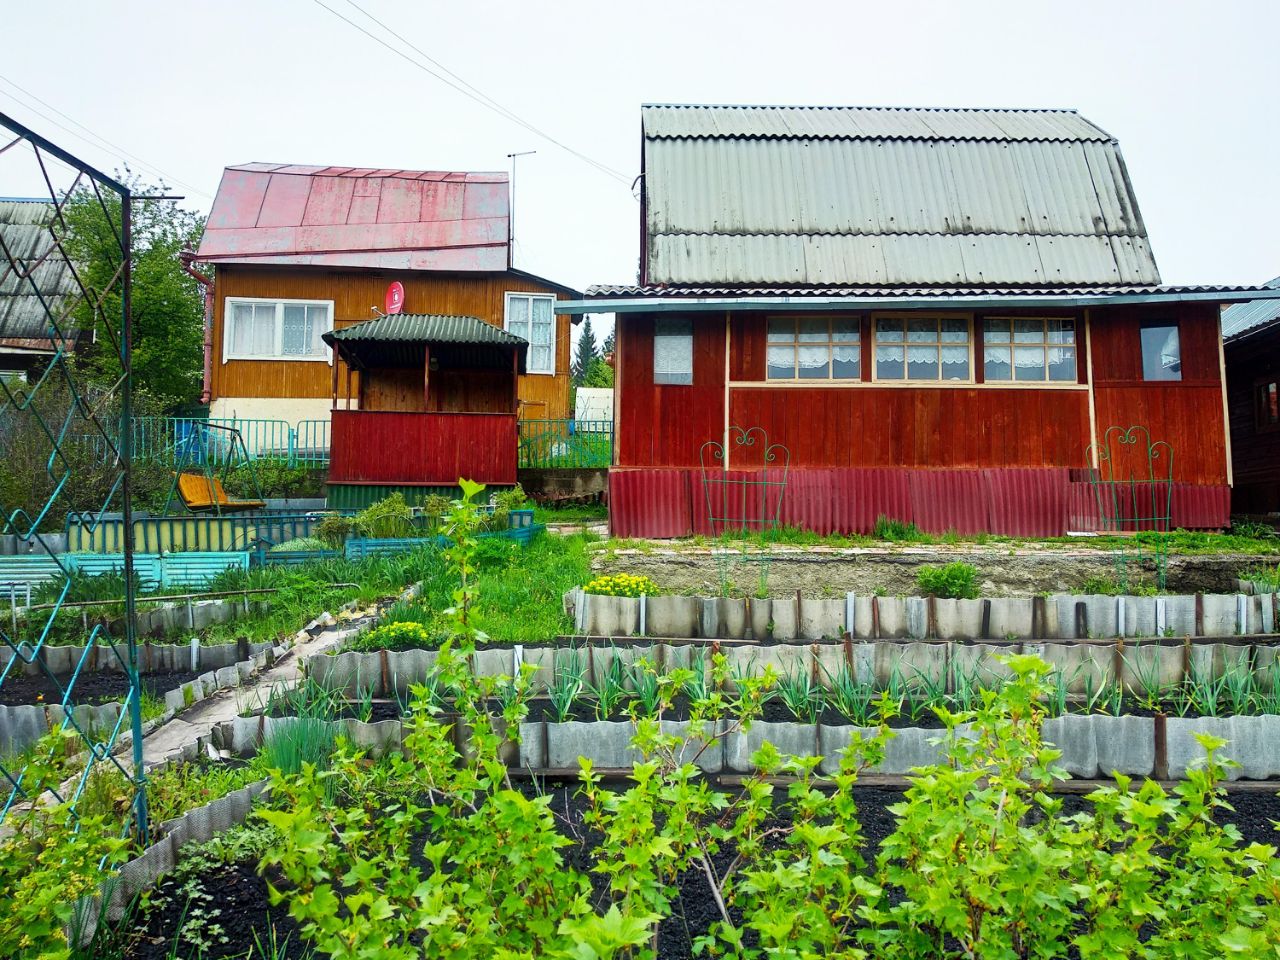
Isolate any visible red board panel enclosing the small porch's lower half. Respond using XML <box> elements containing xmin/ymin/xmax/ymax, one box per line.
<box><xmin>329</xmin><ymin>410</ymin><xmax>518</xmax><ymax>486</ymax></box>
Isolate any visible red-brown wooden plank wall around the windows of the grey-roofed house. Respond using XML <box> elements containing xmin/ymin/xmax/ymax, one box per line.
<box><xmin>617</xmin><ymin>305</ymin><xmax>1226</xmax><ymax>484</ymax></box>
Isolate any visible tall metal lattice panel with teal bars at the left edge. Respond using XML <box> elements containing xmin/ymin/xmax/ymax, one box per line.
<box><xmin>0</xmin><ymin>108</ymin><xmax>147</xmax><ymax>838</ymax></box>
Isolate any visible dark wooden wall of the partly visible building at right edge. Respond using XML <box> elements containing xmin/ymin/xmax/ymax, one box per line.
<box><xmin>1225</xmin><ymin>329</ymin><xmax>1280</xmax><ymax>513</ymax></box>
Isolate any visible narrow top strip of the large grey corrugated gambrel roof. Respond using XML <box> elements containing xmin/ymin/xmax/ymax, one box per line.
<box><xmin>641</xmin><ymin>104</ymin><xmax>1111</xmax><ymax>142</ymax></box>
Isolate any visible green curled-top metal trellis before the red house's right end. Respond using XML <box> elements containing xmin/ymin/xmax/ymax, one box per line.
<box><xmin>1085</xmin><ymin>424</ymin><xmax>1174</xmax><ymax>591</ymax></box>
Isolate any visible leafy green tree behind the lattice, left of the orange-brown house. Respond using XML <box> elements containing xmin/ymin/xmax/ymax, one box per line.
<box><xmin>64</xmin><ymin>170</ymin><xmax>205</xmax><ymax>407</ymax></box>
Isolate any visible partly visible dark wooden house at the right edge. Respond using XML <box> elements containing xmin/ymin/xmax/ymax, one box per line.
<box><xmin>1222</xmin><ymin>276</ymin><xmax>1280</xmax><ymax>513</ymax></box>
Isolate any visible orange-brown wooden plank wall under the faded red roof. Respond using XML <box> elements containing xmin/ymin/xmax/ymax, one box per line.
<box><xmin>211</xmin><ymin>265</ymin><xmax>572</xmax><ymax>420</ymax></box>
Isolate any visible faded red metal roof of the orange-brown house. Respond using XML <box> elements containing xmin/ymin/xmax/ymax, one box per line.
<box><xmin>196</xmin><ymin>164</ymin><xmax>509</xmax><ymax>273</ymax></box>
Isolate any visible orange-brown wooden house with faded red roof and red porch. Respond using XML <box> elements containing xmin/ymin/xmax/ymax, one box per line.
<box><xmin>195</xmin><ymin>164</ymin><xmax>581</xmax><ymax>507</ymax></box>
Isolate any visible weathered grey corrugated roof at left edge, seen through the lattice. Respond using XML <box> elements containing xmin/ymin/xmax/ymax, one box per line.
<box><xmin>0</xmin><ymin>198</ymin><xmax>79</xmax><ymax>349</ymax></box>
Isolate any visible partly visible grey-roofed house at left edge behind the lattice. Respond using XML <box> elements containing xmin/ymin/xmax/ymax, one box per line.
<box><xmin>0</xmin><ymin>197</ymin><xmax>81</xmax><ymax>371</ymax></box>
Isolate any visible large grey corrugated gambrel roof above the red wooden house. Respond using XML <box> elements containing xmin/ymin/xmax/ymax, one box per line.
<box><xmin>641</xmin><ymin>105</ymin><xmax>1160</xmax><ymax>288</ymax></box>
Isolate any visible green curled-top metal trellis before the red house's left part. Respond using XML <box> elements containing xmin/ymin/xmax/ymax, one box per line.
<box><xmin>698</xmin><ymin>426</ymin><xmax>791</xmax><ymax>595</ymax></box>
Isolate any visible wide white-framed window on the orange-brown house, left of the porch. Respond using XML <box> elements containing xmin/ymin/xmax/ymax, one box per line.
<box><xmin>223</xmin><ymin>297</ymin><xmax>333</xmax><ymax>364</ymax></box>
